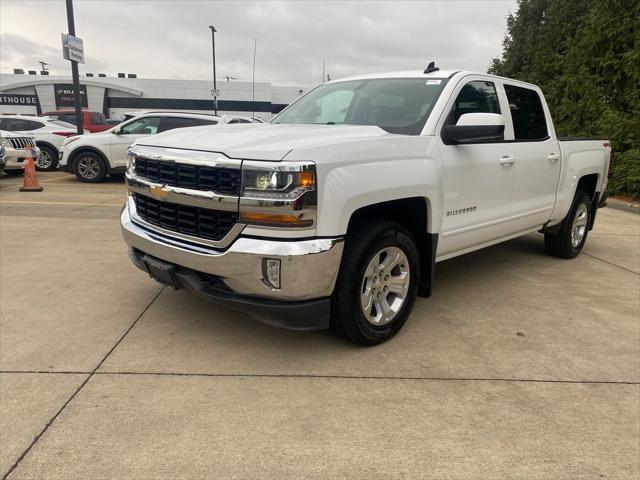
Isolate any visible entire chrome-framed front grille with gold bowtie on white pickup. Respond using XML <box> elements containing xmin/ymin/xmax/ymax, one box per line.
<box><xmin>125</xmin><ymin>145</ymin><xmax>245</xmax><ymax>248</ymax></box>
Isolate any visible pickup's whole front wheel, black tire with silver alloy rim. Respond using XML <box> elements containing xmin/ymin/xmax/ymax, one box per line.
<box><xmin>331</xmin><ymin>220</ymin><xmax>420</xmax><ymax>346</ymax></box>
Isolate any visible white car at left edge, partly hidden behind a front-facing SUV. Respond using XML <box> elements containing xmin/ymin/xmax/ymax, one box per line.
<box><xmin>0</xmin><ymin>115</ymin><xmax>77</xmax><ymax>171</ymax></box>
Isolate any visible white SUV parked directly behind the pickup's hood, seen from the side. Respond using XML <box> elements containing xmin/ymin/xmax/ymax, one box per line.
<box><xmin>60</xmin><ymin>112</ymin><xmax>226</xmax><ymax>183</ymax></box>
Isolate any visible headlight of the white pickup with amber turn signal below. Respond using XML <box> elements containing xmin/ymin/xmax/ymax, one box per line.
<box><xmin>240</xmin><ymin>161</ymin><xmax>317</xmax><ymax>228</ymax></box>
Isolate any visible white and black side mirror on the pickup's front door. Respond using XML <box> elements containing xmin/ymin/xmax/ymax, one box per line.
<box><xmin>442</xmin><ymin>113</ymin><xmax>505</xmax><ymax>145</ymax></box>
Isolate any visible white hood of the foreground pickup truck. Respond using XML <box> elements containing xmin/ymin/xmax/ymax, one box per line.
<box><xmin>136</xmin><ymin>124</ymin><xmax>389</xmax><ymax>161</ymax></box>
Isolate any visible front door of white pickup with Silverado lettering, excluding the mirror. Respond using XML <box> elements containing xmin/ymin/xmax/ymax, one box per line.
<box><xmin>436</xmin><ymin>76</ymin><xmax>515</xmax><ymax>256</ymax></box>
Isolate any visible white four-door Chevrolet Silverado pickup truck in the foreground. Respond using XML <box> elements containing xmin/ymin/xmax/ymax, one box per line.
<box><xmin>121</xmin><ymin>65</ymin><xmax>611</xmax><ymax>345</ymax></box>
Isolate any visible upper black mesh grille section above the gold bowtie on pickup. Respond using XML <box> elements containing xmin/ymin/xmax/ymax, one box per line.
<box><xmin>134</xmin><ymin>158</ymin><xmax>240</xmax><ymax>195</ymax></box>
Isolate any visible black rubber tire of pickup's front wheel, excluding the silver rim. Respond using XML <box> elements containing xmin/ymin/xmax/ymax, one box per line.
<box><xmin>331</xmin><ymin>220</ymin><xmax>420</xmax><ymax>346</ymax></box>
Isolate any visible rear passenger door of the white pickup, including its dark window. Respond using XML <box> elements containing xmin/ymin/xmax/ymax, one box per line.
<box><xmin>504</xmin><ymin>81</ymin><xmax>561</xmax><ymax>230</ymax></box>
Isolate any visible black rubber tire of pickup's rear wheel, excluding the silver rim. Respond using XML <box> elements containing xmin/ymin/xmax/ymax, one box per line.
<box><xmin>544</xmin><ymin>190</ymin><xmax>592</xmax><ymax>258</ymax></box>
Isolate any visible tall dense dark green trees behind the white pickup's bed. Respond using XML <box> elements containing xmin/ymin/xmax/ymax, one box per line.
<box><xmin>489</xmin><ymin>0</ymin><xmax>640</xmax><ymax>198</ymax></box>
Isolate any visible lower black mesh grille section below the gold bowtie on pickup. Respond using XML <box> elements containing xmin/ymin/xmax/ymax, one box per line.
<box><xmin>132</xmin><ymin>193</ymin><xmax>238</xmax><ymax>241</ymax></box>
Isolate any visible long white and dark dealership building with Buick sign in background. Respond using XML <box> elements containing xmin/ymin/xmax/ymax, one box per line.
<box><xmin>0</xmin><ymin>74</ymin><xmax>308</xmax><ymax>120</ymax></box>
